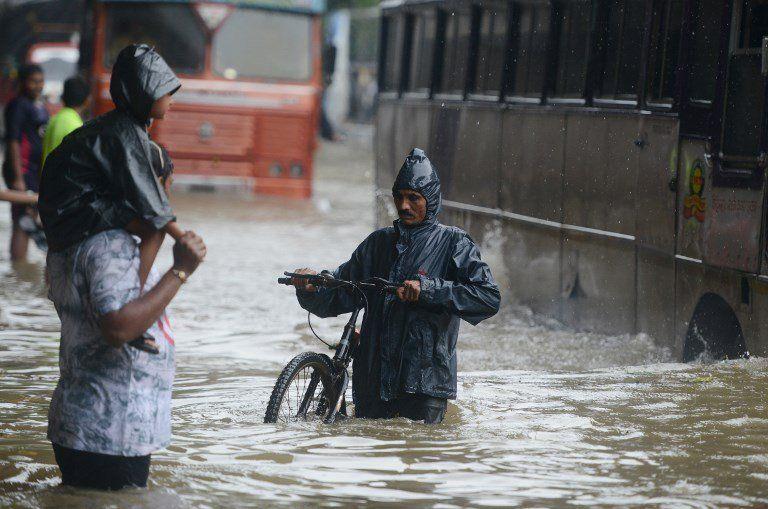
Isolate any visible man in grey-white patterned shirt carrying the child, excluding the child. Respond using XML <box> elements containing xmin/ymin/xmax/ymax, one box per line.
<box><xmin>48</xmin><ymin>143</ymin><xmax>206</xmax><ymax>490</ymax></box>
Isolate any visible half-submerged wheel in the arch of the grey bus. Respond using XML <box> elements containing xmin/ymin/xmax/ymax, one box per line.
<box><xmin>683</xmin><ymin>293</ymin><xmax>749</xmax><ymax>362</ymax></box>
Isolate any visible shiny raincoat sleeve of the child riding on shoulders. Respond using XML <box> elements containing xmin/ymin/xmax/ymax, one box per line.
<box><xmin>106</xmin><ymin>132</ymin><xmax>176</xmax><ymax>230</ymax></box>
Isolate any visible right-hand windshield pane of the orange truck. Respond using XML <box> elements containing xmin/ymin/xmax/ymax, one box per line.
<box><xmin>213</xmin><ymin>9</ymin><xmax>312</xmax><ymax>81</ymax></box>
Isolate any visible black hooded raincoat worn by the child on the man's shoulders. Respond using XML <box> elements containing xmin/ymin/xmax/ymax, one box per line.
<box><xmin>39</xmin><ymin>44</ymin><xmax>181</xmax><ymax>251</ymax></box>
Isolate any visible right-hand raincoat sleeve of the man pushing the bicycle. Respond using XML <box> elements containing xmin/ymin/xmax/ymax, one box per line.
<box><xmin>419</xmin><ymin>235</ymin><xmax>501</xmax><ymax>325</ymax></box>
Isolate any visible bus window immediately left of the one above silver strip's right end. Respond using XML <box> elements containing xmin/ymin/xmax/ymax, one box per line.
<box><xmin>553</xmin><ymin>0</ymin><xmax>592</xmax><ymax>99</ymax></box>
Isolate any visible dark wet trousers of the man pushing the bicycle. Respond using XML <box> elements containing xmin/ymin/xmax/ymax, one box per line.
<box><xmin>355</xmin><ymin>394</ymin><xmax>448</xmax><ymax>424</ymax></box>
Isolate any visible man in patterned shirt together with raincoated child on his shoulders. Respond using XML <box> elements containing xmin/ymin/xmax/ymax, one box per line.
<box><xmin>39</xmin><ymin>45</ymin><xmax>206</xmax><ymax>489</ymax></box>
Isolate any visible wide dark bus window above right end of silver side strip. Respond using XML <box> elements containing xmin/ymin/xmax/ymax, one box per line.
<box><xmin>599</xmin><ymin>0</ymin><xmax>645</xmax><ymax>100</ymax></box>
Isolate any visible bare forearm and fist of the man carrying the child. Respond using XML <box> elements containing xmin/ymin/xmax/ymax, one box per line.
<box><xmin>99</xmin><ymin>232</ymin><xmax>206</xmax><ymax>348</ymax></box>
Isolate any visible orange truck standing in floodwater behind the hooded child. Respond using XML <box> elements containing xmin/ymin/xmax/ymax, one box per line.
<box><xmin>81</xmin><ymin>0</ymin><xmax>324</xmax><ymax>198</ymax></box>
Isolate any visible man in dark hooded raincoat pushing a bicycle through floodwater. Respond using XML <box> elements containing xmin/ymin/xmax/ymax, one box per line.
<box><xmin>294</xmin><ymin>148</ymin><xmax>499</xmax><ymax>423</ymax></box>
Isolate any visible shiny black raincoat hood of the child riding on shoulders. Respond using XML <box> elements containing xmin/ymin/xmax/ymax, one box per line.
<box><xmin>109</xmin><ymin>44</ymin><xmax>181</xmax><ymax>123</ymax></box>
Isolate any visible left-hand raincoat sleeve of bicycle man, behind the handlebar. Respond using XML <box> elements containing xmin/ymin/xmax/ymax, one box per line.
<box><xmin>296</xmin><ymin>235</ymin><xmax>374</xmax><ymax>318</ymax></box>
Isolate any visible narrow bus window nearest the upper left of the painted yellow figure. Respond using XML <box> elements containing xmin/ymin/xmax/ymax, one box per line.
<box><xmin>647</xmin><ymin>0</ymin><xmax>683</xmax><ymax>104</ymax></box>
